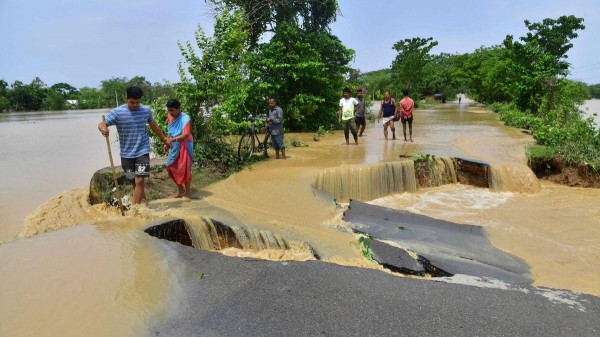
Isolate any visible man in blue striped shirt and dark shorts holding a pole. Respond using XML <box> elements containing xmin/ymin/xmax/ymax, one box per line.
<box><xmin>98</xmin><ymin>86</ymin><xmax>170</xmax><ymax>204</ymax></box>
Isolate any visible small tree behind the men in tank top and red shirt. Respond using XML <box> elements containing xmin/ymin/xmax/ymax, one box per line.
<box><xmin>392</xmin><ymin>37</ymin><xmax>438</xmax><ymax>92</ymax></box>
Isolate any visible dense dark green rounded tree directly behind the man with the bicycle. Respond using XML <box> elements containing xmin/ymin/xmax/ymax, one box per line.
<box><xmin>250</xmin><ymin>23</ymin><xmax>354</xmax><ymax>131</ymax></box>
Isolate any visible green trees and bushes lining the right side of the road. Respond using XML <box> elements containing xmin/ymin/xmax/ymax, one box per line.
<box><xmin>380</xmin><ymin>15</ymin><xmax>600</xmax><ymax>171</ymax></box>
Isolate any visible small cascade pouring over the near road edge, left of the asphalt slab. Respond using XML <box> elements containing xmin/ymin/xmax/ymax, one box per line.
<box><xmin>186</xmin><ymin>217</ymin><xmax>289</xmax><ymax>251</ymax></box>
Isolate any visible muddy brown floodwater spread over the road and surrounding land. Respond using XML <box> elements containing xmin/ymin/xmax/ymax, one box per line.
<box><xmin>0</xmin><ymin>100</ymin><xmax>600</xmax><ymax>336</ymax></box>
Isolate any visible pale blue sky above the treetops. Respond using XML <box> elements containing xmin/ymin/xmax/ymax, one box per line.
<box><xmin>0</xmin><ymin>0</ymin><xmax>600</xmax><ymax>88</ymax></box>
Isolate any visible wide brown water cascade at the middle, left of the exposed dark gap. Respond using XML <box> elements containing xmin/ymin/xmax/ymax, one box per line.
<box><xmin>315</xmin><ymin>160</ymin><xmax>417</xmax><ymax>203</ymax></box>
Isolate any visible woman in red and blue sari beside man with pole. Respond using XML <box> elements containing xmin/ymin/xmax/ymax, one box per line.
<box><xmin>165</xmin><ymin>99</ymin><xmax>194</xmax><ymax>198</ymax></box>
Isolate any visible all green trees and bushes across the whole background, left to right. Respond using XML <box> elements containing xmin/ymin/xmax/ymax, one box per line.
<box><xmin>0</xmin><ymin>5</ymin><xmax>600</xmax><ymax>173</ymax></box>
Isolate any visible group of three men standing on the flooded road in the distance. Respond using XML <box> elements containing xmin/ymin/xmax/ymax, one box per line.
<box><xmin>338</xmin><ymin>88</ymin><xmax>415</xmax><ymax>145</ymax></box>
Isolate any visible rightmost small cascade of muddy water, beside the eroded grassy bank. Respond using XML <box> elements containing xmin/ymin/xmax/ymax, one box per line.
<box><xmin>488</xmin><ymin>164</ymin><xmax>542</xmax><ymax>193</ymax></box>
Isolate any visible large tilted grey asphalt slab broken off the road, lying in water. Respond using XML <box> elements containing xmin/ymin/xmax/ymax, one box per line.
<box><xmin>343</xmin><ymin>200</ymin><xmax>532</xmax><ymax>284</ymax></box>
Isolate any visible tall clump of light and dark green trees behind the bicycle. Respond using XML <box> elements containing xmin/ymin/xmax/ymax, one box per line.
<box><xmin>176</xmin><ymin>1</ymin><xmax>354</xmax><ymax>132</ymax></box>
